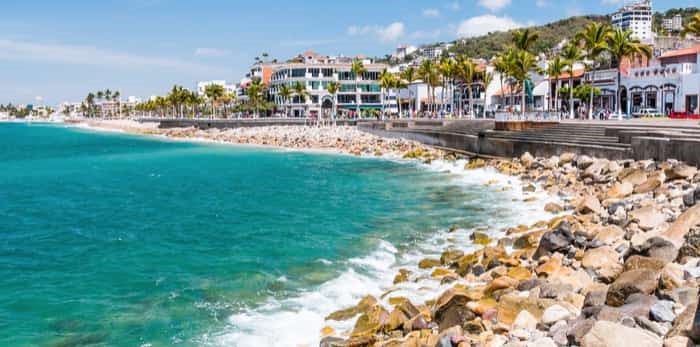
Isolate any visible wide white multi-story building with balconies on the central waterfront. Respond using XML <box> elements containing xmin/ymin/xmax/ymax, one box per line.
<box><xmin>269</xmin><ymin>52</ymin><xmax>388</xmax><ymax>117</ymax></box>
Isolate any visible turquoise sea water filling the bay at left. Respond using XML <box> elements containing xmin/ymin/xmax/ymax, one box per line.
<box><xmin>0</xmin><ymin>124</ymin><xmax>536</xmax><ymax>346</ymax></box>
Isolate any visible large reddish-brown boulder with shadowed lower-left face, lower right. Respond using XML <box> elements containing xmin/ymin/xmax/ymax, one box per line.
<box><xmin>606</xmin><ymin>270</ymin><xmax>659</xmax><ymax>306</ymax></box>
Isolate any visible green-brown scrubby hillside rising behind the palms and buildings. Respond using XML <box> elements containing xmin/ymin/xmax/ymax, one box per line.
<box><xmin>450</xmin><ymin>16</ymin><xmax>610</xmax><ymax>59</ymax></box>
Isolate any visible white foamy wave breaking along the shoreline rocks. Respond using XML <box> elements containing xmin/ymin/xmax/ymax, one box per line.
<box><xmin>198</xmin><ymin>158</ymin><xmax>559</xmax><ymax>347</ymax></box>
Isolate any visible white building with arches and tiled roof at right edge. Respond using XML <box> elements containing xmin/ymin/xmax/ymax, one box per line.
<box><xmin>620</xmin><ymin>45</ymin><xmax>700</xmax><ymax>115</ymax></box>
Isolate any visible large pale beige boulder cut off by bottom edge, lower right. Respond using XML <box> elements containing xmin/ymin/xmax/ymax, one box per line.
<box><xmin>581</xmin><ymin>321</ymin><xmax>663</xmax><ymax>347</ymax></box>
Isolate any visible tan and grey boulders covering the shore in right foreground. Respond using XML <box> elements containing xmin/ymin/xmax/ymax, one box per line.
<box><xmin>320</xmin><ymin>153</ymin><xmax>700</xmax><ymax>347</ymax></box>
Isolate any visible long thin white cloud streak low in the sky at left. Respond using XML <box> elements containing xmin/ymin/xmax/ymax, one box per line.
<box><xmin>0</xmin><ymin>39</ymin><xmax>228</xmax><ymax>73</ymax></box>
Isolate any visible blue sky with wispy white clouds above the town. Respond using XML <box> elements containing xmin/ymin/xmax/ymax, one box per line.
<box><xmin>0</xmin><ymin>0</ymin><xmax>694</xmax><ymax>105</ymax></box>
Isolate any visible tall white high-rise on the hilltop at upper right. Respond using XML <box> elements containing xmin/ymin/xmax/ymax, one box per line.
<box><xmin>612</xmin><ymin>0</ymin><xmax>654</xmax><ymax>43</ymax></box>
